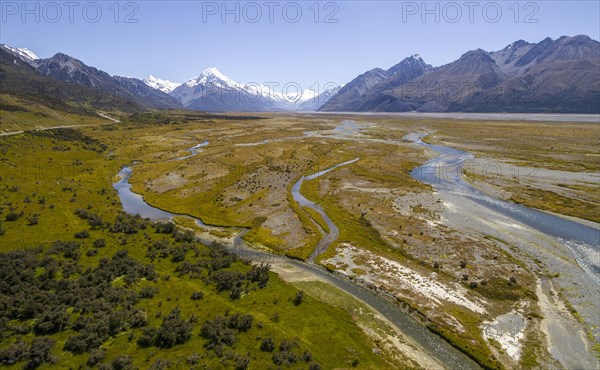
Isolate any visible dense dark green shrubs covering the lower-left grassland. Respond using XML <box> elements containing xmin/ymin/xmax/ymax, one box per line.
<box><xmin>0</xmin><ymin>209</ymin><xmax>330</xmax><ymax>369</ymax></box>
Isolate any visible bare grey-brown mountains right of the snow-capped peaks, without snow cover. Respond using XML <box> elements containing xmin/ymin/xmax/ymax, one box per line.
<box><xmin>321</xmin><ymin>36</ymin><xmax>600</xmax><ymax>113</ymax></box>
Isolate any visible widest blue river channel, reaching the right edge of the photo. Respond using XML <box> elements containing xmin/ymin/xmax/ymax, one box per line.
<box><xmin>406</xmin><ymin>134</ymin><xmax>600</xmax><ymax>281</ymax></box>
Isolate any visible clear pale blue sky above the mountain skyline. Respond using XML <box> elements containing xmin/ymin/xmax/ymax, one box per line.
<box><xmin>0</xmin><ymin>0</ymin><xmax>600</xmax><ymax>89</ymax></box>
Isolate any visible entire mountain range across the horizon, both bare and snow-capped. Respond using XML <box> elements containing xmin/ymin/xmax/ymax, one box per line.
<box><xmin>0</xmin><ymin>36</ymin><xmax>600</xmax><ymax>113</ymax></box>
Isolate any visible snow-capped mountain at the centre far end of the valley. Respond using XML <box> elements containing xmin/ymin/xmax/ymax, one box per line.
<box><xmin>170</xmin><ymin>67</ymin><xmax>332</xmax><ymax>112</ymax></box>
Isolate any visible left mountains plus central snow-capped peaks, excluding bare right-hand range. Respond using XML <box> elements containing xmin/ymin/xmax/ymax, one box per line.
<box><xmin>0</xmin><ymin>44</ymin><xmax>338</xmax><ymax>112</ymax></box>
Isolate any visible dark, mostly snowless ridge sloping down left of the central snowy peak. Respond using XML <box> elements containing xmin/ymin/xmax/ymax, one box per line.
<box><xmin>34</xmin><ymin>53</ymin><xmax>181</xmax><ymax>108</ymax></box>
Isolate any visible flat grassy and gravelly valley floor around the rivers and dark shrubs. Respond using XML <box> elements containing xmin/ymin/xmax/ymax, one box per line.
<box><xmin>0</xmin><ymin>113</ymin><xmax>600</xmax><ymax>369</ymax></box>
